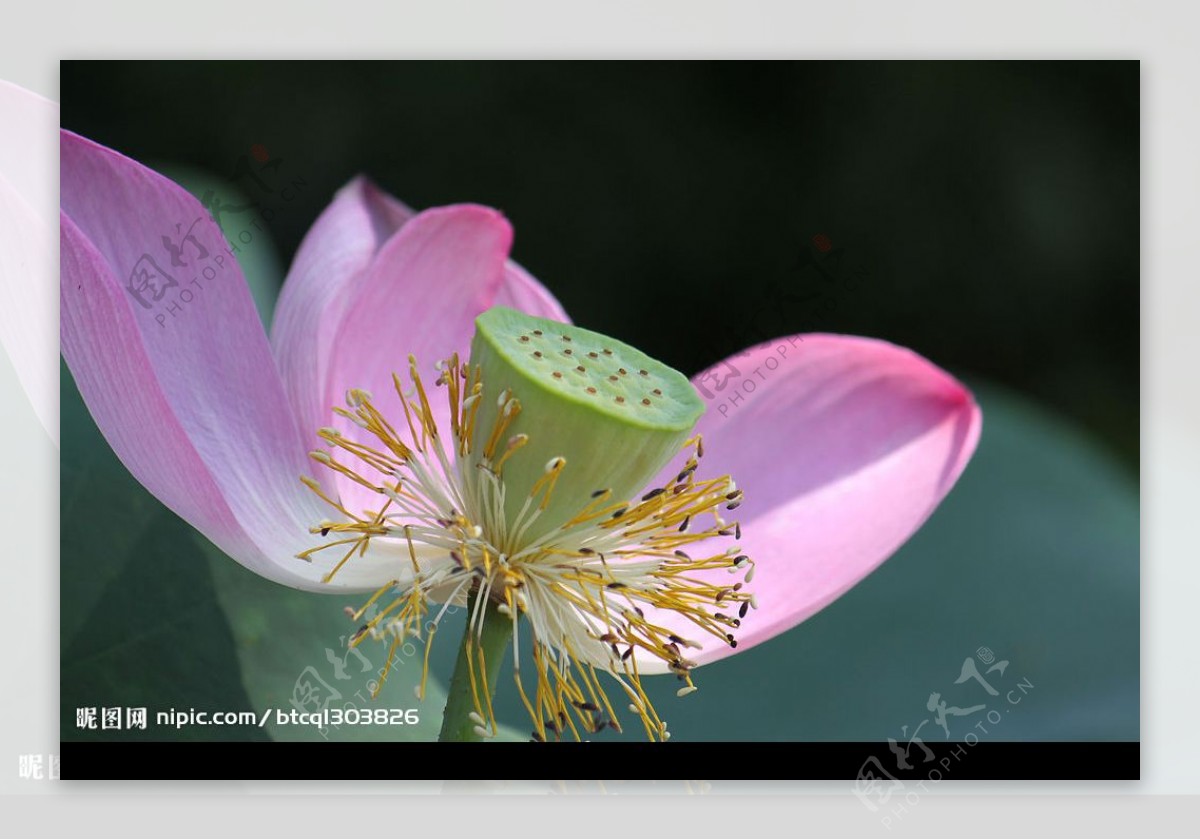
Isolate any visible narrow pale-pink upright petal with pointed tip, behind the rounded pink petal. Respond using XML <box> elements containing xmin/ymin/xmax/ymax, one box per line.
<box><xmin>271</xmin><ymin>178</ymin><xmax>415</xmax><ymax>438</ymax></box>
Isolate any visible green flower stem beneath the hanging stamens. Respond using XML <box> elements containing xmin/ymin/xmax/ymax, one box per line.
<box><xmin>438</xmin><ymin>593</ymin><xmax>512</xmax><ymax>740</ymax></box>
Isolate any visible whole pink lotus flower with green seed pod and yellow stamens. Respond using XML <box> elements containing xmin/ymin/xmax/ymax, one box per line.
<box><xmin>61</xmin><ymin>132</ymin><xmax>980</xmax><ymax>740</ymax></box>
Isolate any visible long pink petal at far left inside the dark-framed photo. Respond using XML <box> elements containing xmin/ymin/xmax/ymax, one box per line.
<box><xmin>60</xmin><ymin>132</ymin><xmax>398</xmax><ymax>589</ymax></box>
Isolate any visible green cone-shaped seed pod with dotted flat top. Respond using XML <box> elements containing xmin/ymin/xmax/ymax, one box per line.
<box><xmin>463</xmin><ymin>307</ymin><xmax>704</xmax><ymax>551</ymax></box>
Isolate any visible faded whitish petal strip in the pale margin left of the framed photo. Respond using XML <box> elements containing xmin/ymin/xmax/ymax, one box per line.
<box><xmin>0</xmin><ymin>80</ymin><xmax>59</xmax><ymax>445</ymax></box>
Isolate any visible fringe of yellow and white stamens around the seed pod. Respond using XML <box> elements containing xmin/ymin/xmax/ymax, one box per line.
<box><xmin>300</xmin><ymin>356</ymin><xmax>756</xmax><ymax>740</ymax></box>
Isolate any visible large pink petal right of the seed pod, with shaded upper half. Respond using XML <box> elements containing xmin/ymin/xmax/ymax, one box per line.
<box><xmin>647</xmin><ymin>335</ymin><xmax>982</xmax><ymax>665</ymax></box>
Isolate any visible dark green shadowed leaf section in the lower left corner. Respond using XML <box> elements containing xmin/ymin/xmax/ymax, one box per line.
<box><xmin>59</xmin><ymin>357</ymin><xmax>264</xmax><ymax>740</ymax></box>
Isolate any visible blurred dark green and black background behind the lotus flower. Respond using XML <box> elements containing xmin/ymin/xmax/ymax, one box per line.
<box><xmin>61</xmin><ymin>62</ymin><xmax>1139</xmax><ymax>739</ymax></box>
